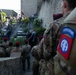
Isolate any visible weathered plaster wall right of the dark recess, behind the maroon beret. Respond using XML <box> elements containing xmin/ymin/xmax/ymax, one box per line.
<box><xmin>39</xmin><ymin>0</ymin><xmax>62</xmax><ymax>28</ymax></box>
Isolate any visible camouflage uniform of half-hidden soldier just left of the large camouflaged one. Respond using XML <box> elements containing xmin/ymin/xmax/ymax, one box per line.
<box><xmin>32</xmin><ymin>45</ymin><xmax>39</xmax><ymax>75</ymax></box>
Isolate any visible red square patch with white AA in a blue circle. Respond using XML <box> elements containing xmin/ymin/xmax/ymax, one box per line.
<box><xmin>58</xmin><ymin>34</ymin><xmax>73</xmax><ymax>59</ymax></box>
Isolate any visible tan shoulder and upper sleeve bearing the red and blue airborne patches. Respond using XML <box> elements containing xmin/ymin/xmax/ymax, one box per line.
<box><xmin>57</xmin><ymin>8</ymin><xmax>76</xmax><ymax>68</ymax></box>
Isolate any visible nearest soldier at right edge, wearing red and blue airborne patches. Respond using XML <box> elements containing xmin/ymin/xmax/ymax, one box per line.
<box><xmin>54</xmin><ymin>7</ymin><xmax>76</xmax><ymax>75</ymax></box>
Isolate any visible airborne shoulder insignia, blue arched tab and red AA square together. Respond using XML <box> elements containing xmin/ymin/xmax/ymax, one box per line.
<box><xmin>58</xmin><ymin>27</ymin><xmax>75</xmax><ymax>60</ymax></box>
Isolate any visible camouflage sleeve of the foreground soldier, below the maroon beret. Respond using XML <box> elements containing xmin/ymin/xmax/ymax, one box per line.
<box><xmin>43</xmin><ymin>22</ymin><xmax>57</xmax><ymax>59</ymax></box>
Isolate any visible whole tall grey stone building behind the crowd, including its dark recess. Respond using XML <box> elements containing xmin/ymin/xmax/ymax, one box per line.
<box><xmin>21</xmin><ymin>0</ymin><xmax>62</xmax><ymax>28</ymax></box>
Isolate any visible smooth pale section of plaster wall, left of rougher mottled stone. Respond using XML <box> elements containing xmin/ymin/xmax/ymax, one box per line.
<box><xmin>38</xmin><ymin>2</ymin><xmax>53</xmax><ymax>28</ymax></box>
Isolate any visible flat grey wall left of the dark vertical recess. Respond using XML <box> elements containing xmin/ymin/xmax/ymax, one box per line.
<box><xmin>21</xmin><ymin>0</ymin><xmax>37</xmax><ymax>17</ymax></box>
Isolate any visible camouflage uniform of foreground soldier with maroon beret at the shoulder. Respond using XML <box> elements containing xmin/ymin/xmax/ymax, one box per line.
<box><xmin>40</xmin><ymin>13</ymin><xmax>69</xmax><ymax>75</ymax></box>
